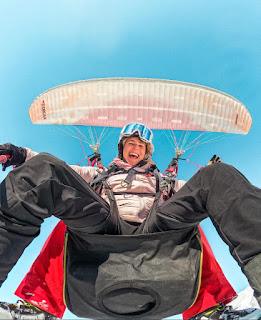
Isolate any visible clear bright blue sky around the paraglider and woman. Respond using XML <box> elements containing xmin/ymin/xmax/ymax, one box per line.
<box><xmin>0</xmin><ymin>0</ymin><xmax>261</xmax><ymax>318</ymax></box>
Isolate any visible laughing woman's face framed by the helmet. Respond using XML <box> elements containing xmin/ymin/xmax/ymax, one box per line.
<box><xmin>123</xmin><ymin>137</ymin><xmax>146</xmax><ymax>166</ymax></box>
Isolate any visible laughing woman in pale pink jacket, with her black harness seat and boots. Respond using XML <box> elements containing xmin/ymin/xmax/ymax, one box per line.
<box><xmin>0</xmin><ymin>123</ymin><xmax>261</xmax><ymax>319</ymax></box>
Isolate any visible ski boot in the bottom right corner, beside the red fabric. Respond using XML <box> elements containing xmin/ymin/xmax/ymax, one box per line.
<box><xmin>189</xmin><ymin>304</ymin><xmax>261</xmax><ymax>320</ymax></box>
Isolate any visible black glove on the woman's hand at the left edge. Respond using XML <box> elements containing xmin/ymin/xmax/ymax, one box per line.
<box><xmin>0</xmin><ymin>143</ymin><xmax>27</xmax><ymax>171</ymax></box>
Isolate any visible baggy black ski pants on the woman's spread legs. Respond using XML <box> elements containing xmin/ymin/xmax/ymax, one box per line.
<box><xmin>0</xmin><ymin>153</ymin><xmax>261</xmax><ymax>304</ymax></box>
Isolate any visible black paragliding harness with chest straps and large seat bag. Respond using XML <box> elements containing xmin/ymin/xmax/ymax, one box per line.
<box><xmin>64</xmin><ymin>156</ymin><xmax>202</xmax><ymax>320</ymax></box>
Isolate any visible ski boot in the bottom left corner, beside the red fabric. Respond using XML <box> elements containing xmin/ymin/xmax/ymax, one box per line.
<box><xmin>0</xmin><ymin>300</ymin><xmax>57</xmax><ymax>320</ymax></box>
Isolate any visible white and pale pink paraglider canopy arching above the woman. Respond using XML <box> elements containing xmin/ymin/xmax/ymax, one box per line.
<box><xmin>29</xmin><ymin>78</ymin><xmax>252</xmax><ymax>134</ymax></box>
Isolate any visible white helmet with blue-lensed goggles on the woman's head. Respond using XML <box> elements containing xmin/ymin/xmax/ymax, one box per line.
<box><xmin>118</xmin><ymin>122</ymin><xmax>154</xmax><ymax>160</ymax></box>
